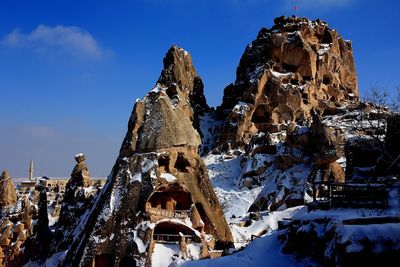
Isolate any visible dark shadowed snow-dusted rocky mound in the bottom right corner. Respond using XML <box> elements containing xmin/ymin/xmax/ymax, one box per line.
<box><xmin>279</xmin><ymin>215</ymin><xmax>400</xmax><ymax>266</ymax></box>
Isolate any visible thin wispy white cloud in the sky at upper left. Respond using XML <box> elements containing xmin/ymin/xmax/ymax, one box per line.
<box><xmin>0</xmin><ymin>25</ymin><xmax>104</xmax><ymax>59</ymax></box>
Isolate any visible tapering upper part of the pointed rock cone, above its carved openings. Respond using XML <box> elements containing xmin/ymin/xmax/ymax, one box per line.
<box><xmin>120</xmin><ymin>46</ymin><xmax>210</xmax><ymax>159</ymax></box>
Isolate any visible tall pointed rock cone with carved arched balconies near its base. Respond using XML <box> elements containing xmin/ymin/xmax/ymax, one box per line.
<box><xmin>63</xmin><ymin>46</ymin><xmax>232</xmax><ymax>266</ymax></box>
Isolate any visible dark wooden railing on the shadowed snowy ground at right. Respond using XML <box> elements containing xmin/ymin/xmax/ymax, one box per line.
<box><xmin>313</xmin><ymin>182</ymin><xmax>387</xmax><ymax>208</ymax></box>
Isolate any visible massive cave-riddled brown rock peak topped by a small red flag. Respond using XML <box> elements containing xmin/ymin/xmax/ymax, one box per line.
<box><xmin>217</xmin><ymin>17</ymin><xmax>358</xmax><ymax>150</ymax></box>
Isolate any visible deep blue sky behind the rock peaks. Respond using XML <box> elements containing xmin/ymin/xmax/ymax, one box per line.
<box><xmin>0</xmin><ymin>0</ymin><xmax>400</xmax><ymax>177</ymax></box>
